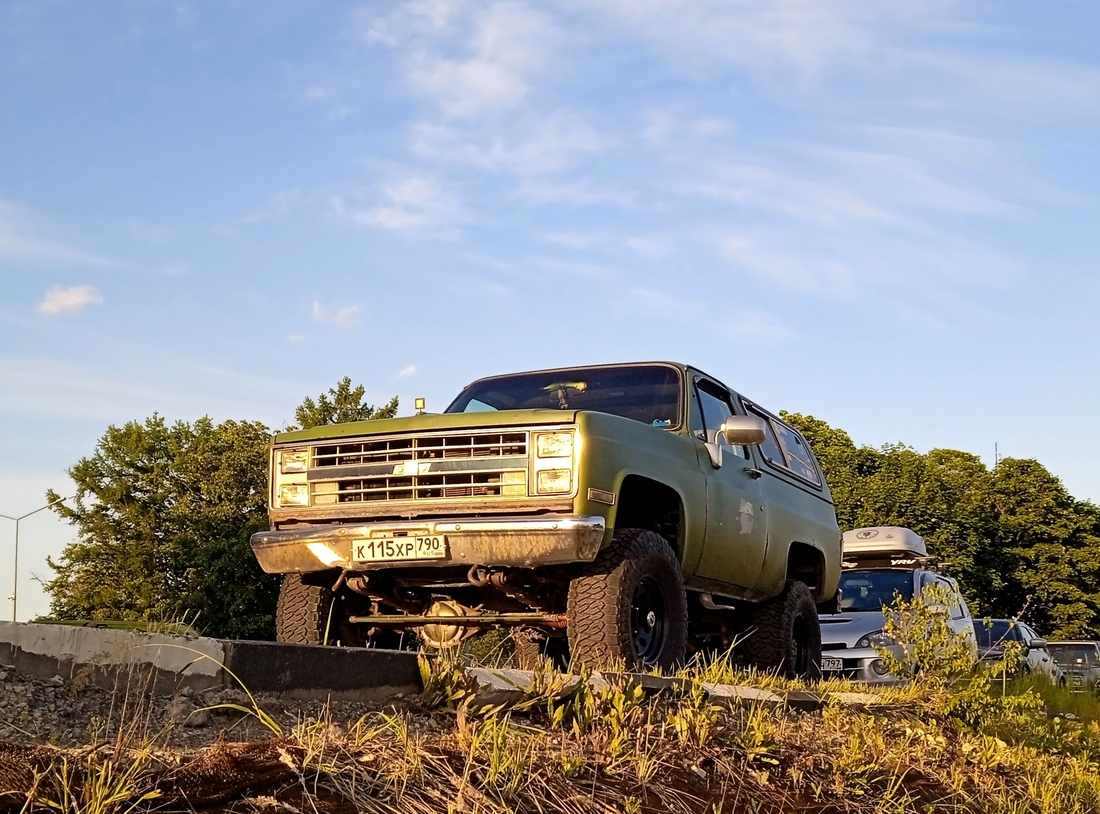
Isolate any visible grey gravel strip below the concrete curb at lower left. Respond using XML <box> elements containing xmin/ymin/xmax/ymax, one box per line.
<box><xmin>0</xmin><ymin>667</ymin><xmax>403</xmax><ymax>747</ymax></box>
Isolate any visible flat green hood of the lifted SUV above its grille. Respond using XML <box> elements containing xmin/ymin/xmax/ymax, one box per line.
<box><xmin>275</xmin><ymin>410</ymin><xmax>578</xmax><ymax>443</ymax></box>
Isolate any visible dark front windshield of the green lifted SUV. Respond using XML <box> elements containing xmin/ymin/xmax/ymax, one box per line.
<box><xmin>446</xmin><ymin>364</ymin><xmax>681</xmax><ymax>429</ymax></box>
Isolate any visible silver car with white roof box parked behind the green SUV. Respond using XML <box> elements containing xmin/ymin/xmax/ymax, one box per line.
<box><xmin>820</xmin><ymin>526</ymin><xmax>978</xmax><ymax>684</ymax></box>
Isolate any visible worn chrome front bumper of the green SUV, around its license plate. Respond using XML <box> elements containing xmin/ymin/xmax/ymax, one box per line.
<box><xmin>251</xmin><ymin>515</ymin><xmax>606</xmax><ymax>574</ymax></box>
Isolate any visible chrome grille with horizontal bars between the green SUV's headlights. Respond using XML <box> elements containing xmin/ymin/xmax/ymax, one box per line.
<box><xmin>309</xmin><ymin>431</ymin><xmax>528</xmax><ymax>506</ymax></box>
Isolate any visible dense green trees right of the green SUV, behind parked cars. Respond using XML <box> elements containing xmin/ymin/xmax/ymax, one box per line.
<box><xmin>783</xmin><ymin>413</ymin><xmax>1100</xmax><ymax>637</ymax></box>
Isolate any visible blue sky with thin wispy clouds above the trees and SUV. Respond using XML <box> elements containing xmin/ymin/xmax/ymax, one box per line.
<box><xmin>0</xmin><ymin>0</ymin><xmax>1100</xmax><ymax>618</ymax></box>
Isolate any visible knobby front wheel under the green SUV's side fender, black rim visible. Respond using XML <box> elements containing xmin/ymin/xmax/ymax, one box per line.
<box><xmin>567</xmin><ymin>529</ymin><xmax>688</xmax><ymax>670</ymax></box>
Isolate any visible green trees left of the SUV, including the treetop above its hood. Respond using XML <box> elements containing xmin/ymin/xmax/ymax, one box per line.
<box><xmin>45</xmin><ymin>378</ymin><xmax>397</xmax><ymax>638</ymax></box>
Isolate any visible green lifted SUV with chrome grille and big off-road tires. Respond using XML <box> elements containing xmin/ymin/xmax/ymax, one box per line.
<box><xmin>252</xmin><ymin>362</ymin><xmax>840</xmax><ymax>679</ymax></box>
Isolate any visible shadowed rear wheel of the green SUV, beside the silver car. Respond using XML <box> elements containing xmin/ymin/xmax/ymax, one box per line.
<box><xmin>745</xmin><ymin>580</ymin><xmax>822</xmax><ymax>681</ymax></box>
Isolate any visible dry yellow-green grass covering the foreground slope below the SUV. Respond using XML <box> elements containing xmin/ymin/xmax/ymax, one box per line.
<box><xmin>0</xmin><ymin>659</ymin><xmax>1100</xmax><ymax>814</ymax></box>
